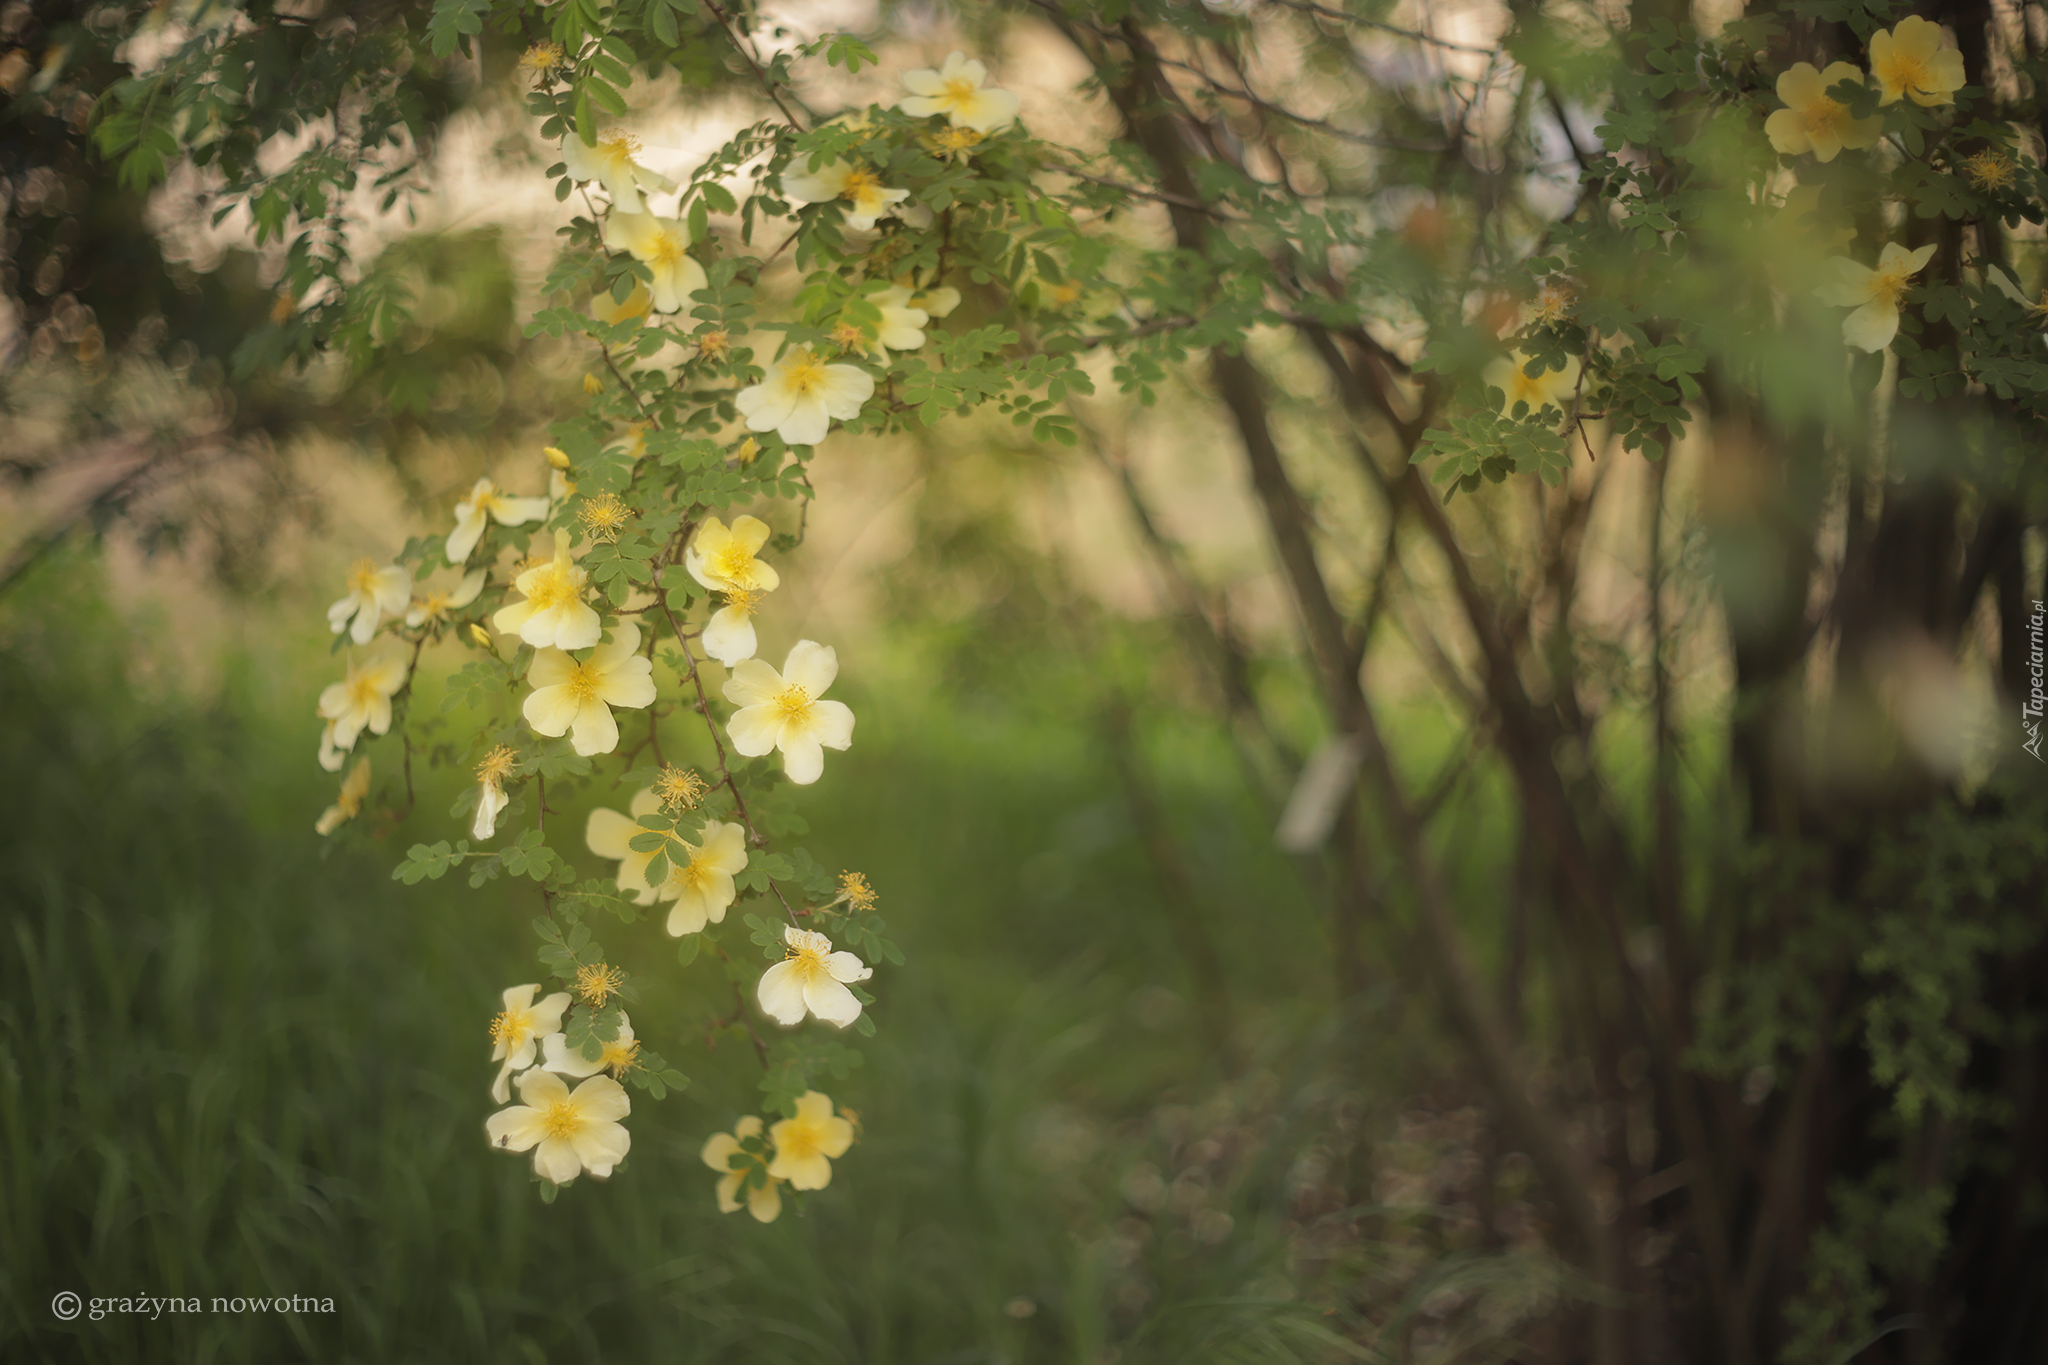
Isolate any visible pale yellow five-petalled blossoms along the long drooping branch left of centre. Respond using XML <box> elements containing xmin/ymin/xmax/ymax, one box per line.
<box><xmin>317</xmin><ymin>43</ymin><xmax>1018</xmax><ymax>1222</ymax></box>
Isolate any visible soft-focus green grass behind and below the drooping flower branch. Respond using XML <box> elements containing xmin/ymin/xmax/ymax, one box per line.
<box><xmin>0</xmin><ymin>565</ymin><xmax>1542</xmax><ymax>1365</ymax></box>
